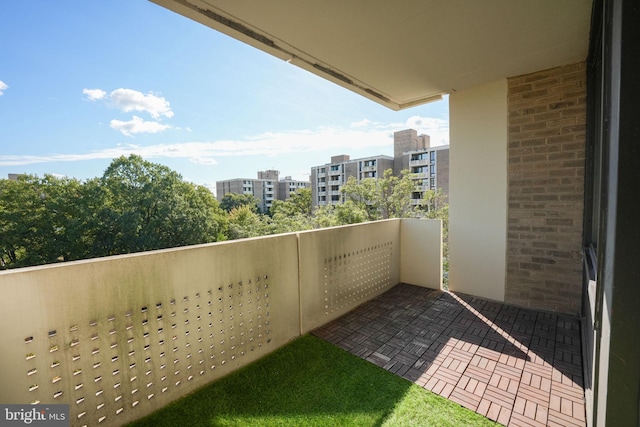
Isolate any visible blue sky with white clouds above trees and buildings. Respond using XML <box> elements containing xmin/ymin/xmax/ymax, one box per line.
<box><xmin>0</xmin><ymin>0</ymin><xmax>449</xmax><ymax>194</ymax></box>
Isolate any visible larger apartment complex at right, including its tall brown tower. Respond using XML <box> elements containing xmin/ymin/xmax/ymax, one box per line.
<box><xmin>311</xmin><ymin>129</ymin><xmax>449</xmax><ymax>206</ymax></box>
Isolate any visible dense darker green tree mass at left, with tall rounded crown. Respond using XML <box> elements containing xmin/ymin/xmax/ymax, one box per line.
<box><xmin>0</xmin><ymin>155</ymin><xmax>228</xmax><ymax>268</ymax></box>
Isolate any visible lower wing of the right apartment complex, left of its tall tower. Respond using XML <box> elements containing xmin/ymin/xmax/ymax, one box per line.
<box><xmin>311</xmin><ymin>154</ymin><xmax>393</xmax><ymax>206</ymax></box>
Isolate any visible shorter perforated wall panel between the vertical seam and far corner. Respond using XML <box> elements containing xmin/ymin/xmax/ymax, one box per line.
<box><xmin>300</xmin><ymin>220</ymin><xmax>400</xmax><ymax>334</ymax></box>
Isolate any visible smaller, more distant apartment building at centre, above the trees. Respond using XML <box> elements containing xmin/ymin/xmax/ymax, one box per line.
<box><xmin>216</xmin><ymin>170</ymin><xmax>311</xmax><ymax>212</ymax></box>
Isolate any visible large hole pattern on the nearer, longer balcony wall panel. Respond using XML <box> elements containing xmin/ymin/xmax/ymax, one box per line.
<box><xmin>21</xmin><ymin>274</ymin><xmax>271</xmax><ymax>425</ymax></box>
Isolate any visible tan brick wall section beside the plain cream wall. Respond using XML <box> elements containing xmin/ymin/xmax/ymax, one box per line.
<box><xmin>505</xmin><ymin>63</ymin><xmax>586</xmax><ymax>313</ymax></box>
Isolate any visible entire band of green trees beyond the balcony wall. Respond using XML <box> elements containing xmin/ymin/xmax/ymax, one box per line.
<box><xmin>0</xmin><ymin>162</ymin><xmax>448</xmax><ymax>269</ymax></box>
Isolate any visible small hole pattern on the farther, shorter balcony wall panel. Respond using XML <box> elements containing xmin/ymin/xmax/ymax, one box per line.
<box><xmin>324</xmin><ymin>242</ymin><xmax>395</xmax><ymax>315</ymax></box>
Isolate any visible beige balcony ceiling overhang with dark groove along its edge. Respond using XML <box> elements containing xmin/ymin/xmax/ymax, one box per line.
<box><xmin>152</xmin><ymin>0</ymin><xmax>592</xmax><ymax>110</ymax></box>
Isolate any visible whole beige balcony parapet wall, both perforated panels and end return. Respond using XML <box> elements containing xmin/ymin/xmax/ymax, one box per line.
<box><xmin>0</xmin><ymin>220</ymin><xmax>442</xmax><ymax>426</ymax></box>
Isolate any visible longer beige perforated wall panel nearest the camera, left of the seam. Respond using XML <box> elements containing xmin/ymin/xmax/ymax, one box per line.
<box><xmin>0</xmin><ymin>235</ymin><xmax>299</xmax><ymax>426</ymax></box>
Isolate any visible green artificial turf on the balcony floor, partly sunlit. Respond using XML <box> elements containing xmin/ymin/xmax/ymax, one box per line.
<box><xmin>131</xmin><ymin>335</ymin><xmax>496</xmax><ymax>427</ymax></box>
